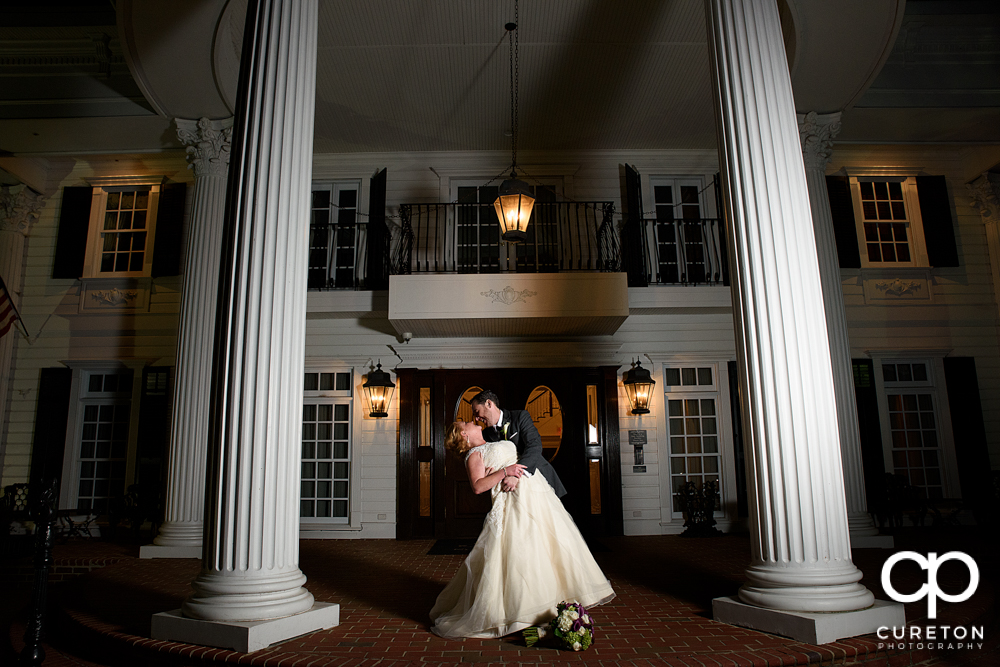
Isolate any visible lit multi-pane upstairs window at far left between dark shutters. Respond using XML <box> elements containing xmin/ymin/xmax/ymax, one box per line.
<box><xmin>87</xmin><ymin>185</ymin><xmax>160</xmax><ymax>277</ymax></box>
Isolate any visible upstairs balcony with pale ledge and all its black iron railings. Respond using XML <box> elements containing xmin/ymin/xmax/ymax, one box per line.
<box><xmin>309</xmin><ymin>202</ymin><xmax>727</xmax><ymax>338</ymax></box>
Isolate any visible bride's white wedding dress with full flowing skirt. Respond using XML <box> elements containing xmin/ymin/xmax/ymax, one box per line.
<box><xmin>431</xmin><ymin>440</ymin><xmax>615</xmax><ymax>637</ymax></box>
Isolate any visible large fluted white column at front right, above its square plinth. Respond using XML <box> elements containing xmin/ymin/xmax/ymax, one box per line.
<box><xmin>706</xmin><ymin>0</ymin><xmax>874</xmax><ymax>612</ymax></box>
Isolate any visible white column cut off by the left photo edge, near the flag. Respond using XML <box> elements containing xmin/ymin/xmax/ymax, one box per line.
<box><xmin>0</xmin><ymin>185</ymin><xmax>45</xmax><ymax>462</ymax></box>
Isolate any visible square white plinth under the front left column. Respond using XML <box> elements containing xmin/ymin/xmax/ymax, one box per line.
<box><xmin>150</xmin><ymin>602</ymin><xmax>340</xmax><ymax>653</ymax></box>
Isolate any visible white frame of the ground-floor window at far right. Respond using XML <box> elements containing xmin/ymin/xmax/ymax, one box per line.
<box><xmin>872</xmin><ymin>358</ymin><xmax>961</xmax><ymax>498</ymax></box>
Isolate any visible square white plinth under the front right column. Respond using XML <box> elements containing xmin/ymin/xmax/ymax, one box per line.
<box><xmin>712</xmin><ymin>597</ymin><xmax>906</xmax><ymax>644</ymax></box>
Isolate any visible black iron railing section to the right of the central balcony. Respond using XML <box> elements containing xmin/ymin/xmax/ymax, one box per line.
<box><xmin>642</xmin><ymin>218</ymin><xmax>726</xmax><ymax>285</ymax></box>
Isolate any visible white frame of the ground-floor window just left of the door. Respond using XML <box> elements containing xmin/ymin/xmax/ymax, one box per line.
<box><xmin>299</xmin><ymin>364</ymin><xmax>361</xmax><ymax>531</ymax></box>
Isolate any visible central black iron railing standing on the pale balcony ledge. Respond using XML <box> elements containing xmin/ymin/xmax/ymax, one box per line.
<box><xmin>390</xmin><ymin>202</ymin><xmax>622</xmax><ymax>274</ymax></box>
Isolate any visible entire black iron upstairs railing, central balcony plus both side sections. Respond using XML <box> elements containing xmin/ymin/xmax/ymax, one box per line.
<box><xmin>308</xmin><ymin>202</ymin><xmax>728</xmax><ymax>290</ymax></box>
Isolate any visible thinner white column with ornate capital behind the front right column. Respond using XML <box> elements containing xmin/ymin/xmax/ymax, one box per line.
<box><xmin>798</xmin><ymin>112</ymin><xmax>893</xmax><ymax>549</ymax></box>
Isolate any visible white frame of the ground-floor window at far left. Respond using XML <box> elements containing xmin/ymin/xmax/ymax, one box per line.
<box><xmin>59</xmin><ymin>361</ymin><xmax>144</xmax><ymax>514</ymax></box>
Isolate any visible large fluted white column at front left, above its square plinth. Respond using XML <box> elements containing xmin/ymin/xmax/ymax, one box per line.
<box><xmin>182</xmin><ymin>0</ymin><xmax>318</xmax><ymax>621</ymax></box>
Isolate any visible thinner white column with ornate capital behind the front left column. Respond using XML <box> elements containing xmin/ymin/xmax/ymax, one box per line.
<box><xmin>139</xmin><ymin>118</ymin><xmax>233</xmax><ymax>558</ymax></box>
